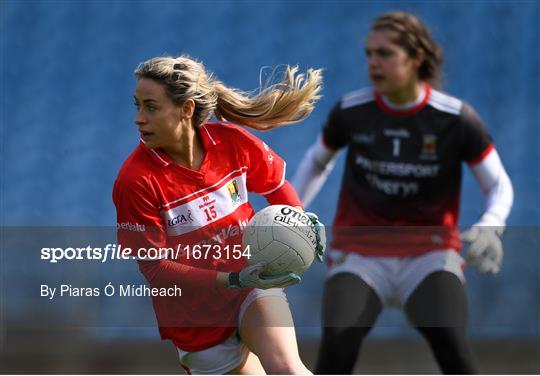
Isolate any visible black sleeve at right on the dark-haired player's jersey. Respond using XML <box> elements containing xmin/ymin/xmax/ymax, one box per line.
<box><xmin>460</xmin><ymin>103</ymin><xmax>493</xmax><ymax>164</ymax></box>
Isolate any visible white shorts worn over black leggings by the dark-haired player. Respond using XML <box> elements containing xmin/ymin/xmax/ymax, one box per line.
<box><xmin>326</xmin><ymin>249</ymin><xmax>465</xmax><ymax>307</ymax></box>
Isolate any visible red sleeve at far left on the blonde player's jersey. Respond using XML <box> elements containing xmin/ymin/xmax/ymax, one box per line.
<box><xmin>113</xmin><ymin>174</ymin><xmax>167</xmax><ymax>259</ymax></box>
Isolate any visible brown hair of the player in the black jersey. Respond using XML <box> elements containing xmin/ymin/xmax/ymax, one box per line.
<box><xmin>371</xmin><ymin>12</ymin><xmax>443</xmax><ymax>87</ymax></box>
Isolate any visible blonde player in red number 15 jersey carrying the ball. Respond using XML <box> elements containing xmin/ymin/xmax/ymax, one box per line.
<box><xmin>113</xmin><ymin>56</ymin><xmax>324</xmax><ymax>374</ymax></box>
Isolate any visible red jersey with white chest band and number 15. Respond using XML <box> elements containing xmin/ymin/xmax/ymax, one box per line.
<box><xmin>113</xmin><ymin>123</ymin><xmax>294</xmax><ymax>352</ymax></box>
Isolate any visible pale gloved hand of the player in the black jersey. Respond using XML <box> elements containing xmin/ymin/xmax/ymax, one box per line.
<box><xmin>461</xmin><ymin>226</ymin><xmax>504</xmax><ymax>274</ymax></box>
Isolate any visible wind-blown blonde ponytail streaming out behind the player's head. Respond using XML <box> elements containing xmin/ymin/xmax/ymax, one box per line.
<box><xmin>214</xmin><ymin>66</ymin><xmax>322</xmax><ymax>131</ymax></box>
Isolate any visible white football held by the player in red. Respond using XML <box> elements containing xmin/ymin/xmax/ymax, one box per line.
<box><xmin>243</xmin><ymin>205</ymin><xmax>317</xmax><ymax>276</ymax></box>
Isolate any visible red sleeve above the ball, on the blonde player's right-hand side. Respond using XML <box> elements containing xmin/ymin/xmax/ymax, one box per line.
<box><xmin>238</xmin><ymin>129</ymin><xmax>286</xmax><ymax>195</ymax></box>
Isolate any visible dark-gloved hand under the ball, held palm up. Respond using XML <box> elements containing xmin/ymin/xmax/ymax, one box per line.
<box><xmin>227</xmin><ymin>263</ymin><xmax>302</xmax><ymax>290</ymax></box>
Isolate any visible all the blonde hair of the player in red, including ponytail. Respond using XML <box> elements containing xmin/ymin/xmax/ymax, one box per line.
<box><xmin>135</xmin><ymin>55</ymin><xmax>322</xmax><ymax>130</ymax></box>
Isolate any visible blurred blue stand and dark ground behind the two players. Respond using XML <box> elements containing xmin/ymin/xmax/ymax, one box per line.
<box><xmin>0</xmin><ymin>0</ymin><xmax>540</xmax><ymax>373</ymax></box>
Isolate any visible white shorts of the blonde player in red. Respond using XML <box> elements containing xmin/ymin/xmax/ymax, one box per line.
<box><xmin>177</xmin><ymin>289</ymin><xmax>286</xmax><ymax>375</ymax></box>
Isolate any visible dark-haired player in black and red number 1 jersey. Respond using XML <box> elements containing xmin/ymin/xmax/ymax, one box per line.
<box><xmin>293</xmin><ymin>12</ymin><xmax>513</xmax><ymax>374</ymax></box>
